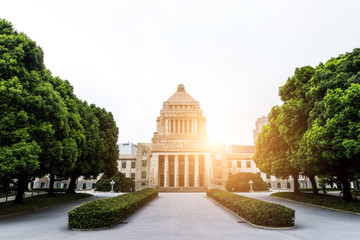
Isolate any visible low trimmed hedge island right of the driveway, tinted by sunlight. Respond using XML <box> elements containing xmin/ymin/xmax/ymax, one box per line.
<box><xmin>206</xmin><ymin>189</ymin><xmax>295</xmax><ymax>227</ymax></box>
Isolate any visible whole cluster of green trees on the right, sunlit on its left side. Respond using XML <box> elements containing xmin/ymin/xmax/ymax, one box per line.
<box><xmin>254</xmin><ymin>49</ymin><xmax>360</xmax><ymax>200</ymax></box>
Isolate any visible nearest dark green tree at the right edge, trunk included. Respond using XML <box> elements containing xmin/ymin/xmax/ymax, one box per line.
<box><xmin>304</xmin><ymin>84</ymin><xmax>360</xmax><ymax>200</ymax></box>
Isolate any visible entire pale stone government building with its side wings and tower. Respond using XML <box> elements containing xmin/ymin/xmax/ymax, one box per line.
<box><xmin>118</xmin><ymin>84</ymin><xmax>304</xmax><ymax>191</ymax></box>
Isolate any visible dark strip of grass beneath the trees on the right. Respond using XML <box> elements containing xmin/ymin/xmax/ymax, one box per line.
<box><xmin>271</xmin><ymin>192</ymin><xmax>360</xmax><ymax>213</ymax></box>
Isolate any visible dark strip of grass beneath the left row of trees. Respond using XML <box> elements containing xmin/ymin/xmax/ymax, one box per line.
<box><xmin>0</xmin><ymin>193</ymin><xmax>92</xmax><ymax>217</ymax></box>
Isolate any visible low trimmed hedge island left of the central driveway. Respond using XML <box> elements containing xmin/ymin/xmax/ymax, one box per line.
<box><xmin>68</xmin><ymin>188</ymin><xmax>158</xmax><ymax>229</ymax></box>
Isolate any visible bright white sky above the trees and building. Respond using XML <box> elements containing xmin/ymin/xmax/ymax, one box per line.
<box><xmin>0</xmin><ymin>0</ymin><xmax>360</xmax><ymax>145</ymax></box>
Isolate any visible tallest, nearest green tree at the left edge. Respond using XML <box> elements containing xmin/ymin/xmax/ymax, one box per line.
<box><xmin>0</xmin><ymin>20</ymin><xmax>70</xmax><ymax>202</ymax></box>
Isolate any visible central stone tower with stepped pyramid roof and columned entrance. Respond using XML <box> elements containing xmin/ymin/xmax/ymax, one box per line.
<box><xmin>135</xmin><ymin>84</ymin><xmax>226</xmax><ymax>191</ymax></box>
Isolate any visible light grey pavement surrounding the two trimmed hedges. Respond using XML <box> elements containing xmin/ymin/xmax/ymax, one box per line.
<box><xmin>0</xmin><ymin>193</ymin><xmax>360</xmax><ymax>240</ymax></box>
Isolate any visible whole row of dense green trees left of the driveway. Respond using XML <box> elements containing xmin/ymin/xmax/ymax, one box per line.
<box><xmin>0</xmin><ymin>19</ymin><xmax>118</xmax><ymax>202</ymax></box>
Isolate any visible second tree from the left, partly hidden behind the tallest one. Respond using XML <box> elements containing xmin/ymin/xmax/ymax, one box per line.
<box><xmin>33</xmin><ymin>73</ymin><xmax>77</xmax><ymax>196</ymax></box>
